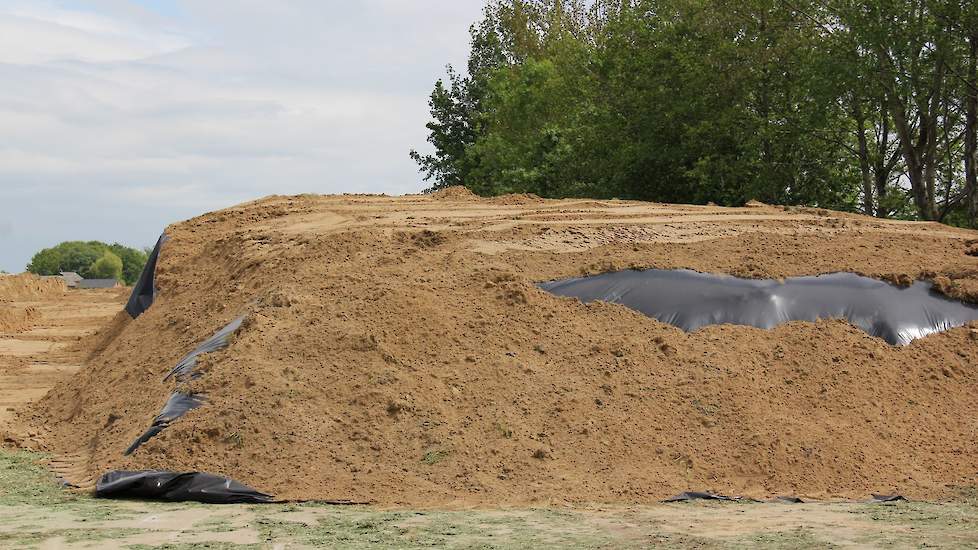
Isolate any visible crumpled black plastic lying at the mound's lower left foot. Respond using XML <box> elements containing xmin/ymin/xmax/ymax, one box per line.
<box><xmin>95</xmin><ymin>470</ymin><xmax>273</xmax><ymax>504</ymax></box>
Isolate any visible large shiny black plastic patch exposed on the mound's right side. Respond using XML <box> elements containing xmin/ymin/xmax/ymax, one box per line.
<box><xmin>539</xmin><ymin>269</ymin><xmax>978</xmax><ymax>345</ymax></box>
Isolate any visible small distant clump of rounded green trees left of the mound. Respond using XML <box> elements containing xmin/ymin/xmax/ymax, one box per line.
<box><xmin>27</xmin><ymin>241</ymin><xmax>148</xmax><ymax>285</ymax></box>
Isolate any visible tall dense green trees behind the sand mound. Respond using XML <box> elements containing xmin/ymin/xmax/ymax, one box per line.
<box><xmin>411</xmin><ymin>0</ymin><xmax>978</xmax><ymax>226</ymax></box>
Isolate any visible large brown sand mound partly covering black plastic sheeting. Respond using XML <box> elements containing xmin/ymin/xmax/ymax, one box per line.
<box><xmin>19</xmin><ymin>192</ymin><xmax>978</xmax><ymax>506</ymax></box>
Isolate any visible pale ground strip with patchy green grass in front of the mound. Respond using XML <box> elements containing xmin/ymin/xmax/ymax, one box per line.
<box><xmin>0</xmin><ymin>450</ymin><xmax>978</xmax><ymax>550</ymax></box>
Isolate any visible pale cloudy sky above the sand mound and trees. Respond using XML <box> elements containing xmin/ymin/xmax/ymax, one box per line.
<box><xmin>0</xmin><ymin>0</ymin><xmax>483</xmax><ymax>273</ymax></box>
